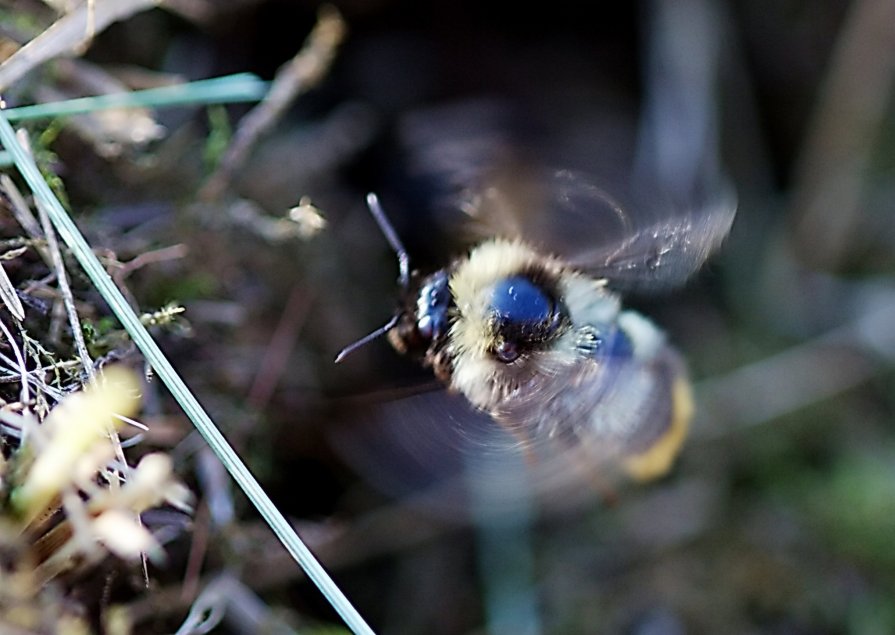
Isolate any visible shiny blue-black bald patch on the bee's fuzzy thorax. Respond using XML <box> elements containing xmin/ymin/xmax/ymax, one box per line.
<box><xmin>490</xmin><ymin>276</ymin><xmax>562</xmax><ymax>363</ymax></box>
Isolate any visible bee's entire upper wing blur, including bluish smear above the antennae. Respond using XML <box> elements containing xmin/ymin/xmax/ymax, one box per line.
<box><xmin>404</xmin><ymin>102</ymin><xmax>736</xmax><ymax>292</ymax></box>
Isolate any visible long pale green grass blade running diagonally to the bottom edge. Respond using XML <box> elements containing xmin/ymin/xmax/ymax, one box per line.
<box><xmin>0</xmin><ymin>112</ymin><xmax>373</xmax><ymax>634</ymax></box>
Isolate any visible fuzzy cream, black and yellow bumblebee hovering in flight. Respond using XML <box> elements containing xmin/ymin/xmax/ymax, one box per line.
<box><xmin>337</xmin><ymin>157</ymin><xmax>736</xmax><ymax>504</ymax></box>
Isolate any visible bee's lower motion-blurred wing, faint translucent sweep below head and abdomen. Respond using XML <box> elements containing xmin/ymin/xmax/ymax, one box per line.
<box><xmin>329</xmin><ymin>391</ymin><xmax>632</xmax><ymax>522</ymax></box>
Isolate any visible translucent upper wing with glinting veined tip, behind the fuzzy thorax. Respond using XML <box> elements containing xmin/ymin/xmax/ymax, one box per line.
<box><xmin>458</xmin><ymin>168</ymin><xmax>736</xmax><ymax>291</ymax></box>
